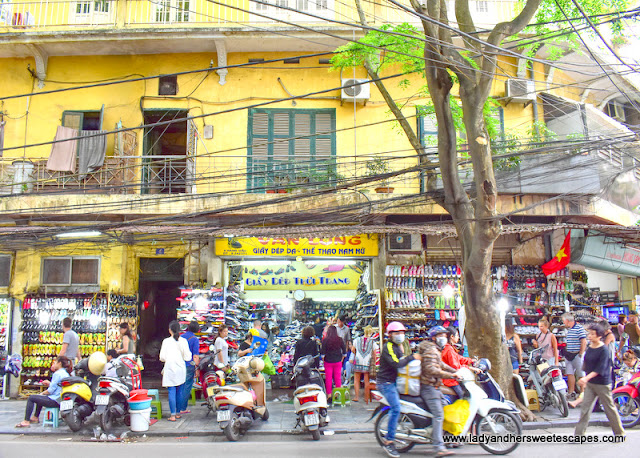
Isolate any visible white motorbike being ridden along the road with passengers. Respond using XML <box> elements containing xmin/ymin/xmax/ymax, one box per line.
<box><xmin>369</xmin><ymin>358</ymin><xmax>522</xmax><ymax>455</ymax></box>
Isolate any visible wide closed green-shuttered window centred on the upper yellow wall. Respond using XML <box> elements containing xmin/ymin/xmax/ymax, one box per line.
<box><xmin>247</xmin><ymin>108</ymin><xmax>336</xmax><ymax>192</ymax></box>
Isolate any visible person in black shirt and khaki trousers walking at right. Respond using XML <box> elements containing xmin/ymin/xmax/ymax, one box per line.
<box><xmin>575</xmin><ymin>323</ymin><xmax>624</xmax><ymax>436</ymax></box>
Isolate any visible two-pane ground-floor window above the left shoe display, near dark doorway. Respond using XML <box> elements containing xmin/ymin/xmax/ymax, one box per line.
<box><xmin>42</xmin><ymin>256</ymin><xmax>100</xmax><ymax>286</ymax></box>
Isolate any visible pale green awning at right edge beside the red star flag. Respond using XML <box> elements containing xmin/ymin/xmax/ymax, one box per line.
<box><xmin>571</xmin><ymin>233</ymin><xmax>640</xmax><ymax>277</ymax></box>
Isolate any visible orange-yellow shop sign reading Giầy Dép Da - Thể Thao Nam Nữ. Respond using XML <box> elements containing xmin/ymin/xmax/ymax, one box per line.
<box><xmin>215</xmin><ymin>234</ymin><xmax>378</xmax><ymax>257</ymax></box>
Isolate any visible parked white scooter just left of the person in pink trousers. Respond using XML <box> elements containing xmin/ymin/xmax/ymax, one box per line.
<box><xmin>291</xmin><ymin>356</ymin><xmax>329</xmax><ymax>441</ymax></box>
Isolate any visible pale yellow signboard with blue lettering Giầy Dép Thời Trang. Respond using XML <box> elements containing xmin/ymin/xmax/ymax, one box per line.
<box><xmin>242</xmin><ymin>261</ymin><xmax>365</xmax><ymax>291</ymax></box>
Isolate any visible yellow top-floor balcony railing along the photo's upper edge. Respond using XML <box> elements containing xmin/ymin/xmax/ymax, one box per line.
<box><xmin>0</xmin><ymin>0</ymin><xmax>515</xmax><ymax>32</ymax></box>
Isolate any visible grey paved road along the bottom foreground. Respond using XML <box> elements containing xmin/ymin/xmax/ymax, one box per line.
<box><xmin>0</xmin><ymin>427</ymin><xmax>640</xmax><ymax>458</ymax></box>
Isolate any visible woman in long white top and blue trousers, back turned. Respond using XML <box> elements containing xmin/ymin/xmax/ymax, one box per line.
<box><xmin>160</xmin><ymin>320</ymin><xmax>191</xmax><ymax>421</ymax></box>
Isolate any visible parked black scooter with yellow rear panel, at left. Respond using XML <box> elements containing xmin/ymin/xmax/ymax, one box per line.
<box><xmin>60</xmin><ymin>358</ymin><xmax>98</xmax><ymax>432</ymax></box>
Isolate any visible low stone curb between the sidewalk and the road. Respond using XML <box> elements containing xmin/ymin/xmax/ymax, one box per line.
<box><xmin>0</xmin><ymin>420</ymin><xmax>609</xmax><ymax>438</ymax></box>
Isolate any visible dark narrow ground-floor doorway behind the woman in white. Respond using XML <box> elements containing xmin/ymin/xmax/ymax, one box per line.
<box><xmin>138</xmin><ymin>258</ymin><xmax>184</xmax><ymax>381</ymax></box>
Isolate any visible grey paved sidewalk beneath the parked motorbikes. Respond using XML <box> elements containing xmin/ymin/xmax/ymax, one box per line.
<box><xmin>0</xmin><ymin>390</ymin><xmax>608</xmax><ymax>437</ymax></box>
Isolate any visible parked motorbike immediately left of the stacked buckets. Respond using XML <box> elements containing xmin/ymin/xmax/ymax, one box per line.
<box><xmin>95</xmin><ymin>356</ymin><xmax>140</xmax><ymax>432</ymax></box>
